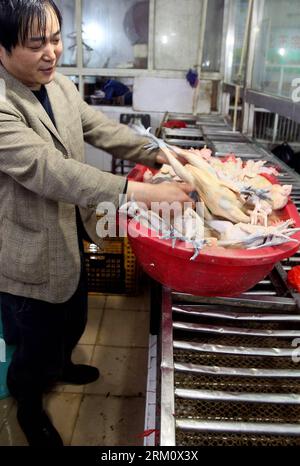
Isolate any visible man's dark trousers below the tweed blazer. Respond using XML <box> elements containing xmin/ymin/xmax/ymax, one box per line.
<box><xmin>0</xmin><ymin>270</ymin><xmax>87</xmax><ymax>402</ymax></box>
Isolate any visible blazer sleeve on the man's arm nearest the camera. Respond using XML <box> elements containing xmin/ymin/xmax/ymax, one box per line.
<box><xmin>0</xmin><ymin>103</ymin><xmax>126</xmax><ymax>209</ymax></box>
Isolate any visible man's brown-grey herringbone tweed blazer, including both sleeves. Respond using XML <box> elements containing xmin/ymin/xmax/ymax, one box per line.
<box><xmin>0</xmin><ymin>65</ymin><xmax>155</xmax><ymax>303</ymax></box>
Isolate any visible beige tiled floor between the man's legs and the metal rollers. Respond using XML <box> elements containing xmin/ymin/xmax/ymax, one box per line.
<box><xmin>0</xmin><ymin>292</ymin><xmax>149</xmax><ymax>446</ymax></box>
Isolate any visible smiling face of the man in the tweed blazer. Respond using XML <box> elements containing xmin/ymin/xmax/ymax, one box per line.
<box><xmin>0</xmin><ymin>7</ymin><xmax>62</xmax><ymax>90</ymax></box>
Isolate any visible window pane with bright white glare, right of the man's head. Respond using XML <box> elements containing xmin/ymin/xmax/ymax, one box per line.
<box><xmin>82</xmin><ymin>0</ymin><xmax>149</xmax><ymax>68</ymax></box>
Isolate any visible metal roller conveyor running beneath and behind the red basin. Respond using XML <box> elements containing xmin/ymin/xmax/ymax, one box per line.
<box><xmin>147</xmin><ymin>114</ymin><xmax>300</xmax><ymax>447</ymax></box>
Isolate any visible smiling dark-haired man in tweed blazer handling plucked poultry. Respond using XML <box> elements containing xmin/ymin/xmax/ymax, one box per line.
<box><xmin>0</xmin><ymin>0</ymin><xmax>189</xmax><ymax>446</ymax></box>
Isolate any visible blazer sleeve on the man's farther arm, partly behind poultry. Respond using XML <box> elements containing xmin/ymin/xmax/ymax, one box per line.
<box><xmin>60</xmin><ymin>78</ymin><xmax>161</xmax><ymax>168</ymax></box>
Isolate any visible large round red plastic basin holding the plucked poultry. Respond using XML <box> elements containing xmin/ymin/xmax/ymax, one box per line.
<box><xmin>121</xmin><ymin>165</ymin><xmax>300</xmax><ymax>296</ymax></box>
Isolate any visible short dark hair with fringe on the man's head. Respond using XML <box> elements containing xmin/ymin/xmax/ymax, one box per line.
<box><xmin>0</xmin><ymin>0</ymin><xmax>62</xmax><ymax>53</ymax></box>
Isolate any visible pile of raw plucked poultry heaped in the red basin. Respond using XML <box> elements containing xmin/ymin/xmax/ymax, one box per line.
<box><xmin>119</xmin><ymin>127</ymin><xmax>299</xmax><ymax>259</ymax></box>
